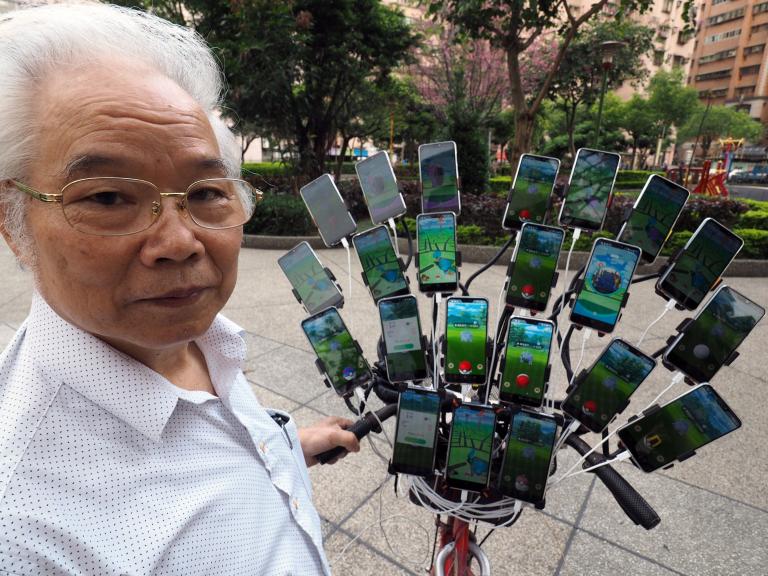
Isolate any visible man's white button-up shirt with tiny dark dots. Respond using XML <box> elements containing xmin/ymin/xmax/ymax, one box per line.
<box><xmin>0</xmin><ymin>296</ymin><xmax>330</xmax><ymax>576</ymax></box>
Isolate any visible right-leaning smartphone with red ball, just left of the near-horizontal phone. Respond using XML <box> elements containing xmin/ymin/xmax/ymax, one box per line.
<box><xmin>562</xmin><ymin>338</ymin><xmax>656</xmax><ymax>432</ymax></box>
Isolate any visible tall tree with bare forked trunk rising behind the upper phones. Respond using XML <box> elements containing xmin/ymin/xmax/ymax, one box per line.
<box><xmin>429</xmin><ymin>0</ymin><xmax>651</xmax><ymax>170</ymax></box>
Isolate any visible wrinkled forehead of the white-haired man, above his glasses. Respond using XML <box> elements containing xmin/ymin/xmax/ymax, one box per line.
<box><xmin>35</xmin><ymin>61</ymin><xmax>223</xmax><ymax>183</ymax></box>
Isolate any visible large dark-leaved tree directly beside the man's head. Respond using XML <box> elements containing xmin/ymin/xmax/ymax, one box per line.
<box><xmin>135</xmin><ymin>0</ymin><xmax>417</xmax><ymax>178</ymax></box>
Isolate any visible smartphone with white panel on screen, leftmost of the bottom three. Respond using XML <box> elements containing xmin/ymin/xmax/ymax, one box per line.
<box><xmin>390</xmin><ymin>386</ymin><xmax>440</xmax><ymax>476</ymax></box>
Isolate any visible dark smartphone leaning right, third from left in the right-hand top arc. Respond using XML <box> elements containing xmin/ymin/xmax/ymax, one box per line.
<box><xmin>616</xmin><ymin>174</ymin><xmax>690</xmax><ymax>262</ymax></box>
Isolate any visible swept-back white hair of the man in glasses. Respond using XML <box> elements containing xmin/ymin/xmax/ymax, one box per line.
<box><xmin>0</xmin><ymin>2</ymin><xmax>240</xmax><ymax>254</ymax></box>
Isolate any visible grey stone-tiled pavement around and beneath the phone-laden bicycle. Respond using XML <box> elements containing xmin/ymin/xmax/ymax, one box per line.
<box><xmin>0</xmin><ymin>244</ymin><xmax>768</xmax><ymax>576</ymax></box>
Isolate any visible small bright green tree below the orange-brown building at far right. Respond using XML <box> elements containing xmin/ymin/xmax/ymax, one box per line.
<box><xmin>677</xmin><ymin>104</ymin><xmax>763</xmax><ymax>158</ymax></box>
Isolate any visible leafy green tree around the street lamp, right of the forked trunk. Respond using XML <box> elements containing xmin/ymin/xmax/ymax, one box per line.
<box><xmin>548</xmin><ymin>19</ymin><xmax>654</xmax><ymax>157</ymax></box>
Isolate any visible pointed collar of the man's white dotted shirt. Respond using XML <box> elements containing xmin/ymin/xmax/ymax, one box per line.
<box><xmin>26</xmin><ymin>294</ymin><xmax>245</xmax><ymax>442</ymax></box>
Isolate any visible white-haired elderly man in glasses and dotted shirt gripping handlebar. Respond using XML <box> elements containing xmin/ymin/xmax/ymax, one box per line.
<box><xmin>0</xmin><ymin>4</ymin><xmax>358</xmax><ymax>576</ymax></box>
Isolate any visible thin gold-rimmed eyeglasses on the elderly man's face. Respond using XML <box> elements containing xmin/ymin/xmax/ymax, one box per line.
<box><xmin>13</xmin><ymin>177</ymin><xmax>262</xmax><ymax>236</ymax></box>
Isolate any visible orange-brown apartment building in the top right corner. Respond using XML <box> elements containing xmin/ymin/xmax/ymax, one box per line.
<box><xmin>688</xmin><ymin>0</ymin><xmax>768</xmax><ymax>123</ymax></box>
